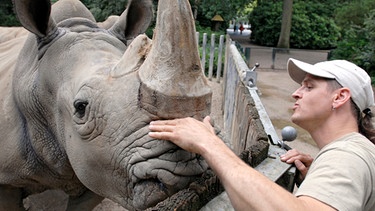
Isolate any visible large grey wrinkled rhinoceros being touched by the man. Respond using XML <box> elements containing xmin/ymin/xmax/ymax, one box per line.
<box><xmin>0</xmin><ymin>0</ymin><xmax>212</xmax><ymax>210</ymax></box>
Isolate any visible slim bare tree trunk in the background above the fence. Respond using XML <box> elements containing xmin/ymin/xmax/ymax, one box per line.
<box><xmin>277</xmin><ymin>0</ymin><xmax>293</xmax><ymax>48</ymax></box>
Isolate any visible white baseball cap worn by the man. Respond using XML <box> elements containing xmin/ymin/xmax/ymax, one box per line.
<box><xmin>287</xmin><ymin>58</ymin><xmax>374</xmax><ymax>111</ymax></box>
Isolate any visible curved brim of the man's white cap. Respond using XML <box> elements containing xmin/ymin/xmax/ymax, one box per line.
<box><xmin>287</xmin><ymin>58</ymin><xmax>335</xmax><ymax>84</ymax></box>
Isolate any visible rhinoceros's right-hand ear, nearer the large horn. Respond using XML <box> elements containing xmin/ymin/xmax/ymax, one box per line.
<box><xmin>109</xmin><ymin>0</ymin><xmax>153</xmax><ymax>43</ymax></box>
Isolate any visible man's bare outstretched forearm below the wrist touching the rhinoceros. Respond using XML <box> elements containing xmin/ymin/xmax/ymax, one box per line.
<box><xmin>202</xmin><ymin>138</ymin><xmax>308</xmax><ymax>210</ymax></box>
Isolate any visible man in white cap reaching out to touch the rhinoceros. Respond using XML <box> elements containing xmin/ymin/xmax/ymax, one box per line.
<box><xmin>149</xmin><ymin>59</ymin><xmax>375</xmax><ymax>210</ymax></box>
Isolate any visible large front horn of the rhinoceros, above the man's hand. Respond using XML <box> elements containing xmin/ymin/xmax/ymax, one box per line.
<box><xmin>139</xmin><ymin>0</ymin><xmax>212</xmax><ymax>119</ymax></box>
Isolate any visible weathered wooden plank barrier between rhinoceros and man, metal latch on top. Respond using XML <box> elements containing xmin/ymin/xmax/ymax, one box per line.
<box><xmin>201</xmin><ymin>36</ymin><xmax>296</xmax><ymax>211</ymax></box>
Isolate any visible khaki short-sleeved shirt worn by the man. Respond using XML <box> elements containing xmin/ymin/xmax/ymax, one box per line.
<box><xmin>296</xmin><ymin>133</ymin><xmax>375</xmax><ymax>211</ymax></box>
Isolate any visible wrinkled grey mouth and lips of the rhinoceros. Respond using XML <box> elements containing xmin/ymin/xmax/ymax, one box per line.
<box><xmin>133</xmin><ymin>150</ymin><xmax>207</xmax><ymax>210</ymax></box>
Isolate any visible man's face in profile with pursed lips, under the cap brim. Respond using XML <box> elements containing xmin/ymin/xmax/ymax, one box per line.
<box><xmin>291</xmin><ymin>74</ymin><xmax>335</xmax><ymax>132</ymax></box>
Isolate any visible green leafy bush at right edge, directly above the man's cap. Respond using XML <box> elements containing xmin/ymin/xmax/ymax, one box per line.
<box><xmin>331</xmin><ymin>0</ymin><xmax>375</xmax><ymax>77</ymax></box>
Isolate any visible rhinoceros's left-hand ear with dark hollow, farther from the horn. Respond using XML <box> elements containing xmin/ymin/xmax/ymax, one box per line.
<box><xmin>13</xmin><ymin>0</ymin><xmax>56</xmax><ymax>37</ymax></box>
